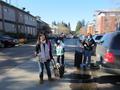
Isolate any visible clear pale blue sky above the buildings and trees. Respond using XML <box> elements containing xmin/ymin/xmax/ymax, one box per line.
<box><xmin>11</xmin><ymin>0</ymin><xmax>120</xmax><ymax>29</ymax></box>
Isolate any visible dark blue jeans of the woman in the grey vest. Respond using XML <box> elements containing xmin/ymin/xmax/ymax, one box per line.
<box><xmin>40</xmin><ymin>61</ymin><xmax>51</xmax><ymax>79</ymax></box>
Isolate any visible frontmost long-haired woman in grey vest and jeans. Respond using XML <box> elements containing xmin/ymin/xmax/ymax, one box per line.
<box><xmin>35</xmin><ymin>34</ymin><xmax>53</xmax><ymax>84</ymax></box>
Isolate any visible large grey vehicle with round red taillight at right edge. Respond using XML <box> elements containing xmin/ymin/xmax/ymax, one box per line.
<box><xmin>96</xmin><ymin>31</ymin><xmax>120</xmax><ymax>74</ymax></box>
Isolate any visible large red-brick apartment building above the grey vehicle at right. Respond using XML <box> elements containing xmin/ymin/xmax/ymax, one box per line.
<box><xmin>95</xmin><ymin>10</ymin><xmax>120</xmax><ymax>34</ymax></box>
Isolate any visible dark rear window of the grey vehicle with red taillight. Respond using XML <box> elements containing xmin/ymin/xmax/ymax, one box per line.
<box><xmin>111</xmin><ymin>34</ymin><xmax>120</xmax><ymax>50</ymax></box>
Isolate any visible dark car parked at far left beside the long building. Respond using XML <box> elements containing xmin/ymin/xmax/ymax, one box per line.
<box><xmin>0</xmin><ymin>35</ymin><xmax>16</xmax><ymax>47</ymax></box>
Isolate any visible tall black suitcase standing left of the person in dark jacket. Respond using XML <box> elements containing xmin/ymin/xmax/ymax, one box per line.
<box><xmin>74</xmin><ymin>51</ymin><xmax>83</xmax><ymax>68</ymax></box>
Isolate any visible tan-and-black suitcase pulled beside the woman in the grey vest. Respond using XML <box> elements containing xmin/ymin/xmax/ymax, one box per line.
<box><xmin>51</xmin><ymin>59</ymin><xmax>64</xmax><ymax>78</ymax></box>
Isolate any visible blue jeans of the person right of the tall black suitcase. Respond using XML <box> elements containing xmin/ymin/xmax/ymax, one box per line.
<box><xmin>83</xmin><ymin>50</ymin><xmax>92</xmax><ymax>66</ymax></box>
